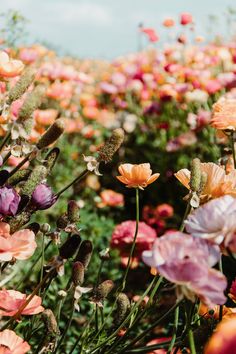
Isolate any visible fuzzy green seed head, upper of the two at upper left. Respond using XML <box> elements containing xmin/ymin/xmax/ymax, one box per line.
<box><xmin>7</xmin><ymin>68</ymin><xmax>35</xmax><ymax>104</ymax></box>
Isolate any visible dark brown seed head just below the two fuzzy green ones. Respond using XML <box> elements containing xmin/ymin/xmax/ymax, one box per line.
<box><xmin>36</xmin><ymin>118</ymin><xmax>65</xmax><ymax>150</ymax></box>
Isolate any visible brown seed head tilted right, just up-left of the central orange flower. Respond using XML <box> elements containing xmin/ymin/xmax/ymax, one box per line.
<box><xmin>98</xmin><ymin>128</ymin><xmax>124</xmax><ymax>162</ymax></box>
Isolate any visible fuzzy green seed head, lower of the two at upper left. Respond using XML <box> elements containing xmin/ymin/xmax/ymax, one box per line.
<box><xmin>17</xmin><ymin>86</ymin><xmax>45</xmax><ymax>123</ymax></box>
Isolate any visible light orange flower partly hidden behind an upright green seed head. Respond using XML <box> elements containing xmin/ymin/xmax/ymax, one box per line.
<box><xmin>175</xmin><ymin>162</ymin><xmax>236</xmax><ymax>202</ymax></box>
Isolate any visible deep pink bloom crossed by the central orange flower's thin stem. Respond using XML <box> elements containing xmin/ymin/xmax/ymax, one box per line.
<box><xmin>111</xmin><ymin>220</ymin><xmax>156</xmax><ymax>257</ymax></box>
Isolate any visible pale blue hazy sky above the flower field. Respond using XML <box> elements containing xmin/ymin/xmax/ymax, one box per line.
<box><xmin>0</xmin><ymin>0</ymin><xmax>236</xmax><ymax>59</ymax></box>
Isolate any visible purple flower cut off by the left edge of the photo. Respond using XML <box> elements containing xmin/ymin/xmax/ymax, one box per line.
<box><xmin>0</xmin><ymin>186</ymin><xmax>21</xmax><ymax>216</ymax></box>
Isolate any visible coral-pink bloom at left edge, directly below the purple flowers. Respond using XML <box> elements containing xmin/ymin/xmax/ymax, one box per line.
<box><xmin>0</xmin><ymin>222</ymin><xmax>37</xmax><ymax>262</ymax></box>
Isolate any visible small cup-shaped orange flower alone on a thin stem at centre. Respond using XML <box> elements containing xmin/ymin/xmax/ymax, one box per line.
<box><xmin>116</xmin><ymin>163</ymin><xmax>160</xmax><ymax>189</ymax></box>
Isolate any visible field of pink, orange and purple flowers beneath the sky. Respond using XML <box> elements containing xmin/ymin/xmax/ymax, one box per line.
<box><xmin>0</xmin><ymin>9</ymin><xmax>236</xmax><ymax>354</ymax></box>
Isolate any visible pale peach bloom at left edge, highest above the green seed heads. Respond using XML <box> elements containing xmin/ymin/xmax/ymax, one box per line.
<box><xmin>0</xmin><ymin>51</ymin><xmax>24</xmax><ymax>78</ymax></box>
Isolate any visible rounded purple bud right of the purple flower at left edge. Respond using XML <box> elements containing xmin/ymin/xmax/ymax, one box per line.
<box><xmin>31</xmin><ymin>183</ymin><xmax>57</xmax><ymax>210</ymax></box>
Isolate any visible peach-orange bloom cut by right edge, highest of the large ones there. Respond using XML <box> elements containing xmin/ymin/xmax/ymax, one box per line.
<box><xmin>211</xmin><ymin>97</ymin><xmax>236</xmax><ymax>130</ymax></box>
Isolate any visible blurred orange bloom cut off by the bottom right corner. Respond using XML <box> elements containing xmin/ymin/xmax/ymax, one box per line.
<box><xmin>204</xmin><ymin>317</ymin><xmax>236</xmax><ymax>354</ymax></box>
